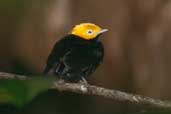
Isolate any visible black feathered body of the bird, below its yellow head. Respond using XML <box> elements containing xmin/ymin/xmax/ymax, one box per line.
<box><xmin>44</xmin><ymin>35</ymin><xmax>104</xmax><ymax>82</ymax></box>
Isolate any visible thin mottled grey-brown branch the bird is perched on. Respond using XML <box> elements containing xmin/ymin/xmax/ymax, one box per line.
<box><xmin>0</xmin><ymin>72</ymin><xmax>171</xmax><ymax>110</ymax></box>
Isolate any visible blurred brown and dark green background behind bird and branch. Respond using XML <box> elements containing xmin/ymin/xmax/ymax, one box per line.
<box><xmin>0</xmin><ymin>0</ymin><xmax>171</xmax><ymax>114</ymax></box>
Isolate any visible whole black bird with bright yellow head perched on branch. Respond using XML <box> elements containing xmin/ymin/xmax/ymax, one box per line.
<box><xmin>43</xmin><ymin>23</ymin><xmax>108</xmax><ymax>83</ymax></box>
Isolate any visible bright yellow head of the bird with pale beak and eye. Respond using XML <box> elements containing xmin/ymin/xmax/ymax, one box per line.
<box><xmin>71</xmin><ymin>23</ymin><xmax>108</xmax><ymax>40</ymax></box>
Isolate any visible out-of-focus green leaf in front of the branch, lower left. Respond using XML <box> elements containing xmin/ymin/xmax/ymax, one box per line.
<box><xmin>0</xmin><ymin>77</ymin><xmax>54</xmax><ymax>107</ymax></box>
